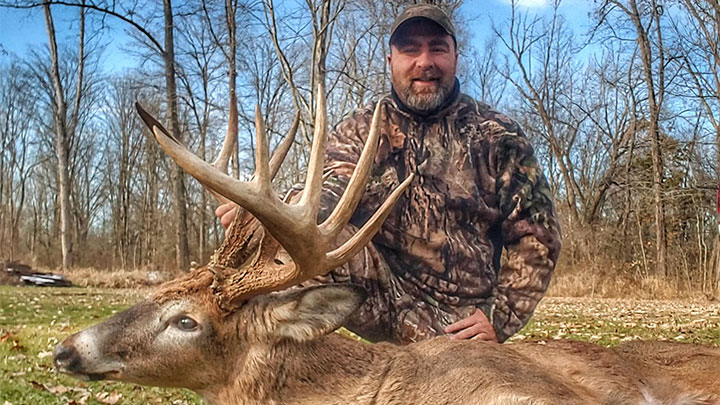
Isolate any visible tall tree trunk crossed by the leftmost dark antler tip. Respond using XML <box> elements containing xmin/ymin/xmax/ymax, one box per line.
<box><xmin>163</xmin><ymin>0</ymin><xmax>190</xmax><ymax>270</ymax></box>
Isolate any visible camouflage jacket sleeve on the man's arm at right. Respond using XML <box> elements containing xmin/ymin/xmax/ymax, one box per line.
<box><xmin>484</xmin><ymin>127</ymin><xmax>561</xmax><ymax>342</ymax></box>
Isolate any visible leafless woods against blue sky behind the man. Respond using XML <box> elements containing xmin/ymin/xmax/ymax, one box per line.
<box><xmin>0</xmin><ymin>0</ymin><xmax>720</xmax><ymax>293</ymax></box>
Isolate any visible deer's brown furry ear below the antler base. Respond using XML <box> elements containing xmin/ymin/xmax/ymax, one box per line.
<box><xmin>272</xmin><ymin>284</ymin><xmax>367</xmax><ymax>342</ymax></box>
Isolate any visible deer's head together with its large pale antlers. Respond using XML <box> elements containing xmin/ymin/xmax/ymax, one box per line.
<box><xmin>54</xmin><ymin>76</ymin><xmax>412</xmax><ymax>391</ymax></box>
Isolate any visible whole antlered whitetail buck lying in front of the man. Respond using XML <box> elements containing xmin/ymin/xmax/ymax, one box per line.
<box><xmin>54</xmin><ymin>78</ymin><xmax>720</xmax><ymax>405</ymax></box>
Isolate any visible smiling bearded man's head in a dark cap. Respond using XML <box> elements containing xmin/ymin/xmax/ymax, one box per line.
<box><xmin>388</xmin><ymin>19</ymin><xmax>457</xmax><ymax>111</ymax></box>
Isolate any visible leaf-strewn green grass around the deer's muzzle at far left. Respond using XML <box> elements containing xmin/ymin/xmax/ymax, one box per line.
<box><xmin>0</xmin><ymin>286</ymin><xmax>203</xmax><ymax>405</ymax></box>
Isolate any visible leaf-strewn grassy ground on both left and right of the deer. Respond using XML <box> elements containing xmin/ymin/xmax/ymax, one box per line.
<box><xmin>0</xmin><ymin>286</ymin><xmax>720</xmax><ymax>405</ymax></box>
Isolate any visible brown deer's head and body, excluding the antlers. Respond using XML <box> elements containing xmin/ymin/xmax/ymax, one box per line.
<box><xmin>56</xmin><ymin>280</ymin><xmax>720</xmax><ymax>405</ymax></box>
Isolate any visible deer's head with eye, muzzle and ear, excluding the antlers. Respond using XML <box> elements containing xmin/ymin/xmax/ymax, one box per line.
<box><xmin>55</xmin><ymin>270</ymin><xmax>364</xmax><ymax>397</ymax></box>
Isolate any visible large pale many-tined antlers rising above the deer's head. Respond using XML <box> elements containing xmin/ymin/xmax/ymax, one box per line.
<box><xmin>136</xmin><ymin>84</ymin><xmax>413</xmax><ymax>302</ymax></box>
